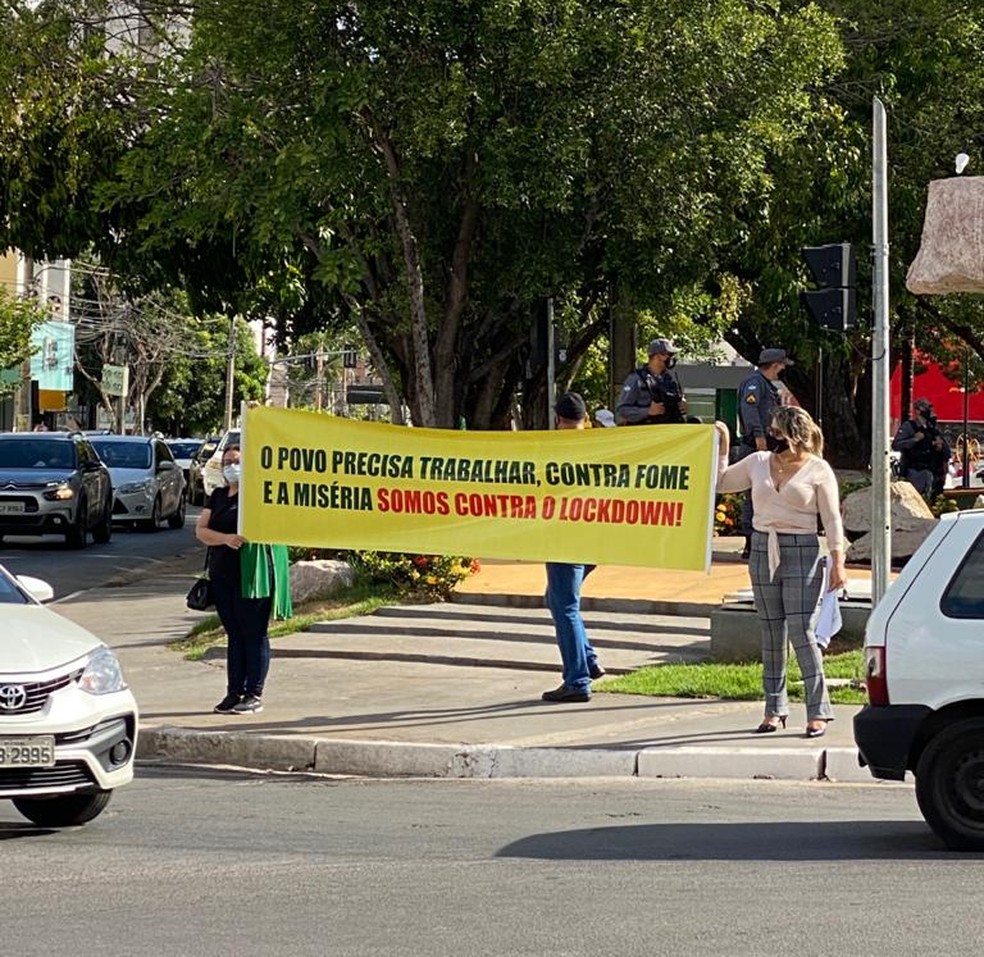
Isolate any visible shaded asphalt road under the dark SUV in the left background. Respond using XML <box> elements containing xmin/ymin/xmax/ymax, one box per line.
<box><xmin>0</xmin><ymin>507</ymin><xmax>201</xmax><ymax>599</ymax></box>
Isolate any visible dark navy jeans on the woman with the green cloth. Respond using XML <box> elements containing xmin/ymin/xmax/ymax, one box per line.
<box><xmin>212</xmin><ymin>578</ymin><xmax>272</xmax><ymax>698</ymax></box>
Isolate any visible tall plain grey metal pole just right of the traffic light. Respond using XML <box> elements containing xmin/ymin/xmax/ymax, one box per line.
<box><xmin>871</xmin><ymin>96</ymin><xmax>892</xmax><ymax>608</ymax></box>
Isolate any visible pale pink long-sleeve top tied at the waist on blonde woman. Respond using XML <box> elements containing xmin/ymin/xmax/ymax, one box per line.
<box><xmin>717</xmin><ymin>452</ymin><xmax>844</xmax><ymax>574</ymax></box>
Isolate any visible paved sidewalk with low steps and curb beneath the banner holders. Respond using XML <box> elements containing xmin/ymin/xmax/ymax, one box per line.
<box><xmin>55</xmin><ymin>539</ymin><xmax>884</xmax><ymax>782</ymax></box>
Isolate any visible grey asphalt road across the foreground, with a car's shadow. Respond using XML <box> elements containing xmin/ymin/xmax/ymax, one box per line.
<box><xmin>0</xmin><ymin>768</ymin><xmax>981</xmax><ymax>957</ymax></box>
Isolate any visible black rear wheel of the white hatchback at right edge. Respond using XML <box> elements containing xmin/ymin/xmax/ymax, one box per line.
<box><xmin>916</xmin><ymin>718</ymin><xmax>984</xmax><ymax>851</ymax></box>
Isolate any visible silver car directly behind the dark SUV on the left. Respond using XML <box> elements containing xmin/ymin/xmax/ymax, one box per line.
<box><xmin>92</xmin><ymin>435</ymin><xmax>186</xmax><ymax>531</ymax></box>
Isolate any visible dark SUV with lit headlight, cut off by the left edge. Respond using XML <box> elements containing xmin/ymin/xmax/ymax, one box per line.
<box><xmin>0</xmin><ymin>432</ymin><xmax>113</xmax><ymax>548</ymax></box>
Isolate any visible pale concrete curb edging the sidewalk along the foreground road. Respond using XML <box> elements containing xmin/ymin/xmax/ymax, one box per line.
<box><xmin>137</xmin><ymin>727</ymin><xmax>875</xmax><ymax>784</ymax></box>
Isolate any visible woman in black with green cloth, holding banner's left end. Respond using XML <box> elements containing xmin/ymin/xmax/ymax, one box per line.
<box><xmin>195</xmin><ymin>445</ymin><xmax>292</xmax><ymax>714</ymax></box>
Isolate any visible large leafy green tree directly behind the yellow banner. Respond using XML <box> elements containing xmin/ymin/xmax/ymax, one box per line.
<box><xmin>96</xmin><ymin>0</ymin><xmax>840</xmax><ymax>427</ymax></box>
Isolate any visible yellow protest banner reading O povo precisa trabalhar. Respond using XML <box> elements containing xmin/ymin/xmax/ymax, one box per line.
<box><xmin>239</xmin><ymin>407</ymin><xmax>716</xmax><ymax>570</ymax></box>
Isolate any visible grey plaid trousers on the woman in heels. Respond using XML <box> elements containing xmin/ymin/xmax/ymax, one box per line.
<box><xmin>748</xmin><ymin>532</ymin><xmax>834</xmax><ymax>721</ymax></box>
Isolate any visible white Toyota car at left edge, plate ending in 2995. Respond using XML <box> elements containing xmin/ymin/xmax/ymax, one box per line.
<box><xmin>0</xmin><ymin>566</ymin><xmax>137</xmax><ymax>827</ymax></box>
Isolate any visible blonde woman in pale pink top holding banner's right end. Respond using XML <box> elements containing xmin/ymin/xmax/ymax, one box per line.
<box><xmin>717</xmin><ymin>406</ymin><xmax>846</xmax><ymax>738</ymax></box>
